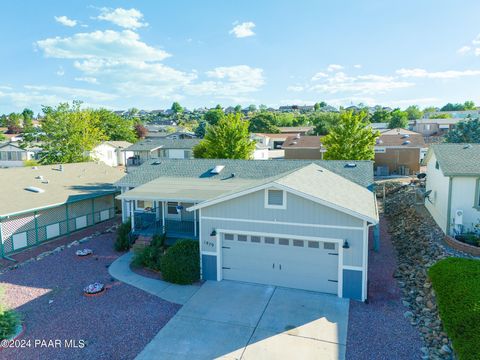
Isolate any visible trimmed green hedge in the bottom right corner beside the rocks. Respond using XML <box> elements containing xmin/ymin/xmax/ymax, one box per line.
<box><xmin>429</xmin><ymin>258</ymin><xmax>480</xmax><ymax>360</ymax></box>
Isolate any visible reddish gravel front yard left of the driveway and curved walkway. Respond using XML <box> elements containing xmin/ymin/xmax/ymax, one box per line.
<box><xmin>0</xmin><ymin>234</ymin><xmax>180</xmax><ymax>360</ymax></box>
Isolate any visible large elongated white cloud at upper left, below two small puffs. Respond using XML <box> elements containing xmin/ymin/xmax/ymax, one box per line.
<box><xmin>36</xmin><ymin>30</ymin><xmax>170</xmax><ymax>61</ymax></box>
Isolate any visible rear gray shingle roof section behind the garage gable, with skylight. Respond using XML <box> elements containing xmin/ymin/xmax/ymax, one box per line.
<box><xmin>116</xmin><ymin>159</ymin><xmax>373</xmax><ymax>187</ymax></box>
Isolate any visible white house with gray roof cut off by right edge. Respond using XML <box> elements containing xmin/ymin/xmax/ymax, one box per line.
<box><xmin>424</xmin><ymin>144</ymin><xmax>480</xmax><ymax>235</ymax></box>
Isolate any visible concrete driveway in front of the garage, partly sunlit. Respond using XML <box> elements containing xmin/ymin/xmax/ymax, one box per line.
<box><xmin>137</xmin><ymin>281</ymin><xmax>349</xmax><ymax>360</ymax></box>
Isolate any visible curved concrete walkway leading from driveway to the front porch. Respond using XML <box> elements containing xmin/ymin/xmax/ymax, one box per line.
<box><xmin>108</xmin><ymin>252</ymin><xmax>201</xmax><ymax>305</ymax></box>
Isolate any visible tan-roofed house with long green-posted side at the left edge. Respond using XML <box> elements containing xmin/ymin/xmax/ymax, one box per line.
<box><xmin>0</xmin><ymin>162</ymin><xmax>124</xmax><ymax>257</ymax></box>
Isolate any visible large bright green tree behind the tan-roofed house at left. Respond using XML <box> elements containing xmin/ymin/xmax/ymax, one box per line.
<box><xmin>39</xmin><ymin>101</ymin><xmax>106</xmax><ymax>164</ymax></box>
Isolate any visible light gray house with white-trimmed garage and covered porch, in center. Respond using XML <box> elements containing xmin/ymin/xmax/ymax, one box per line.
<box><xmin>116</xmin><ymin>159</ymin><xmax>378</xmax><ymax>301</ymax></box>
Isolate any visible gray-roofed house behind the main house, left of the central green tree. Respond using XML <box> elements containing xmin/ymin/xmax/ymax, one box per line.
<box><xmin>125</xmin><ymin>139</ymin><xmax>200</xmax><ymax>166</ymax></box>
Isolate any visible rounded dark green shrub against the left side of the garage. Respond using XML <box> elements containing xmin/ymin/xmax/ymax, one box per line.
<box><xmin>161</xmin><ymin>240</ymin><xmax>200</xmax><ymax>284</ymax></box>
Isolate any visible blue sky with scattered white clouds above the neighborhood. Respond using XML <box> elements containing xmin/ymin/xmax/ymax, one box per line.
<box><xmin>0</xmin><ymin>0</ymin><xmax>480</xmax><ymax>113</ymax></box>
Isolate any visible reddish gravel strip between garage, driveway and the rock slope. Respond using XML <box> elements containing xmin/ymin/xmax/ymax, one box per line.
<box><xmin>346</xmin><ymin>218</ymin><xmax>423</xmax><ymax>360</ymax></box>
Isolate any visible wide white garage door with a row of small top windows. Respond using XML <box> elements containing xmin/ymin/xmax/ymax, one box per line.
<box><xmin>222</xmin><ymin>233</ymin><xmax>338</xmax><ymax>294</ymax></box>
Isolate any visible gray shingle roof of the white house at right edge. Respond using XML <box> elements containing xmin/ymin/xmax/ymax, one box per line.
<box><xmin>430</xmin><ymin>144</ymin><xmax>480</xmax><ymax>176</ymax></box>
